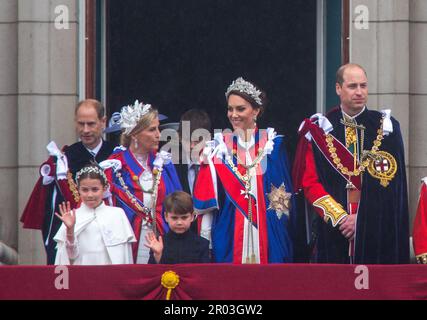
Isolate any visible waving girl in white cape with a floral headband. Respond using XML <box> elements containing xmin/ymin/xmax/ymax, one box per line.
<box><xmin>54</xmin><ymin>164</ymin><xmax>136</xmax><ymax>265</ymax></box>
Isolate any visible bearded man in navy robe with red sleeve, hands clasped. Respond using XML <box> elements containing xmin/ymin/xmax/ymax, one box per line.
<box><xmin>293</xmin><ymin>64</ymin><xmax>409</xmax><ymax>264</ymax></box>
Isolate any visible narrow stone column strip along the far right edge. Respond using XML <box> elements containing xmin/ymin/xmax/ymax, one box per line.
<box><xmin>409</xmin><ymin>0</ymin><xmax>427</xmax><ymax>227</ymax></box>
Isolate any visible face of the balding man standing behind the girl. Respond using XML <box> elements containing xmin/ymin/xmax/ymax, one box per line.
<box><xmin>75</xmin><ymin>104</ymin><xmax>106</xmax><ymax>149</ymax></box>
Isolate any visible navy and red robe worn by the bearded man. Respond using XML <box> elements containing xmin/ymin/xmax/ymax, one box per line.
<box><xmin>293</xmin><ymin>107</ymin><xmax>409</xmax><ymax>264</ymax></box>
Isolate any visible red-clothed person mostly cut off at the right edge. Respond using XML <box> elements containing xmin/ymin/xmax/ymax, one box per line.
<box><xmin>413</xmin><ymin>177</ymin><xmax>427</xmax><ymax>264</ymax></box>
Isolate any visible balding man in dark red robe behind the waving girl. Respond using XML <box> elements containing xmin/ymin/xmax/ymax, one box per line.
<box><xmin>21</xmin><ymin>99</ymin><xmax>114</xmax><ymax>264</ymax></box>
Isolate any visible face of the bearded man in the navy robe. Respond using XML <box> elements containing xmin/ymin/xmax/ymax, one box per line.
<box><xmin>336</xmin><ymin>67</ymin><xmax>368</xmax><ymax>116</ymax></box>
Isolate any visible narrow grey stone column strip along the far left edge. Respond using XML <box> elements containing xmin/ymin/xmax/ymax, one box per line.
<box><xmin>0</xmin><ymin>0</ymin><xmax>18</xmax><ymax>263</ymax></box>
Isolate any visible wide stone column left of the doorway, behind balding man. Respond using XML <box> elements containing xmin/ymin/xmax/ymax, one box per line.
<box><xmin>17</xmin><ymin>0</ymin><xmax>78</xmax><ymax>264</ymax></box>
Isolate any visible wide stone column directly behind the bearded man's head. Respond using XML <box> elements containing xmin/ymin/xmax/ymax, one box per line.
<box><xmin>350</xmin><ymin>0</ymin><xmax>409</xmax><ymax>159</ymax></box>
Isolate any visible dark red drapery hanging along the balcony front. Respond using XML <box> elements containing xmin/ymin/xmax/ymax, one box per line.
<box><xmin>0</xmin><ymin>264</ymin><xmax>427</xmax><ymax>300</ymax></box>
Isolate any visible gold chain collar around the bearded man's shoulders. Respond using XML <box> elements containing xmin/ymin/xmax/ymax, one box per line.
<box><xmin>326</xmin><ymin>117</ymin><xmax>384</xmax><ymax>177</ymax></box>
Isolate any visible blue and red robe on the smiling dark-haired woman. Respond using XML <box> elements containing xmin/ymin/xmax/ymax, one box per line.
<box><xmin>194</xmin><ymin>130</ymin><xmax>295</xmax><ymax>264</ymax></box>
